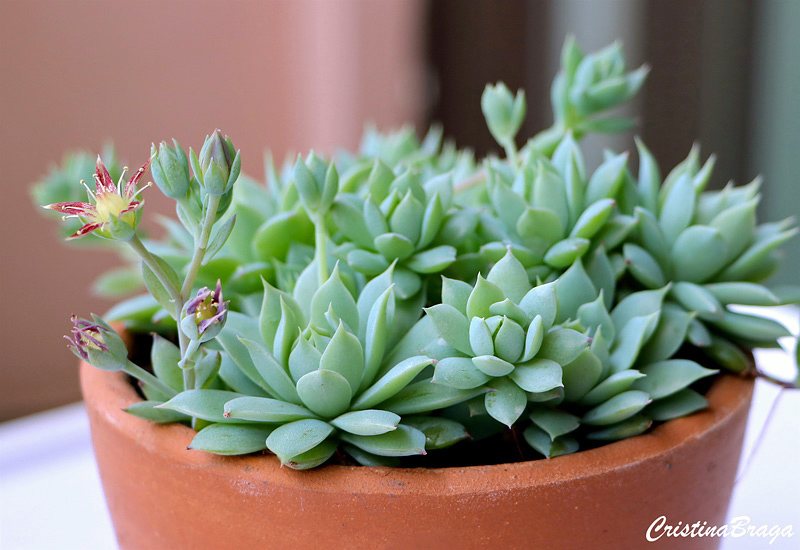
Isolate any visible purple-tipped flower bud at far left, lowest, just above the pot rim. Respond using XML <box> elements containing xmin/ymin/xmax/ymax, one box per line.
<box><xmin>64</xmin><ymin>315</ymin><xmax>128</xmax><ymax>371</ymax></box>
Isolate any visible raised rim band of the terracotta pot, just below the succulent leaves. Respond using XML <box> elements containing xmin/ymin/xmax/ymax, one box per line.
<box><xmin>80</xmin><ymin>362</ymin><xmax>754</xmax><ymax>496</ymax></box>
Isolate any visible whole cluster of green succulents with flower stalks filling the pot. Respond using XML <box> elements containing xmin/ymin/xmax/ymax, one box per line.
<box><xmin>36</xmin><ymin>40</ymin><xmax>798</xmax><ymax>469</ymax></box>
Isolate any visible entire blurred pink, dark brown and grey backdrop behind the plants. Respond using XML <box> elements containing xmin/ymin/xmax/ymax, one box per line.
<box><xmin>0</xmin><ymin>0</ymin><xmax>800</xmax><ymax>421</ymax></box>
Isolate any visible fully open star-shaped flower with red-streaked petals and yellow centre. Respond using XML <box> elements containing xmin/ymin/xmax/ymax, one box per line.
<box><xmin>42</xmin><ymin>156</ymin><xmax>150</xmax><ymax>239</ymax></box>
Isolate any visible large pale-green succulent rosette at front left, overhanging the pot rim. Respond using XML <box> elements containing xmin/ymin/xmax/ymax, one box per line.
<box><xmin>157</xmin><ymin>267</ymin><xmax>484</xmax><ymax>469</ymax></box>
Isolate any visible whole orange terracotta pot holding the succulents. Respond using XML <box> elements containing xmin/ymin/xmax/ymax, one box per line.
<box><xmin>81</xmin><ymin>364</ymin><xmax>753</xmax><ymax>550</ymax></box>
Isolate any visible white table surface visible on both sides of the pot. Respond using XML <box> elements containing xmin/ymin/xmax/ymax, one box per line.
<box><xmin>0</xmin><ymin>308</ymin><xmax>800</xmax><ymax>550</ymax></box>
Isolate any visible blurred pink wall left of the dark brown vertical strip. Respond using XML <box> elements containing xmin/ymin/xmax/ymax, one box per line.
<box><xmin>0</xmin><ymin>0</ymin><xmax>423</xmax><ymax>420</ymax></box>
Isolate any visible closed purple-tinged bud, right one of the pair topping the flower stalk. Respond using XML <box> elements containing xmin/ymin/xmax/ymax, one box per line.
<box><xmin>189</xmin><ymin>130</ymin><xmax>242</xmax><ymax>196</ymax></box>
